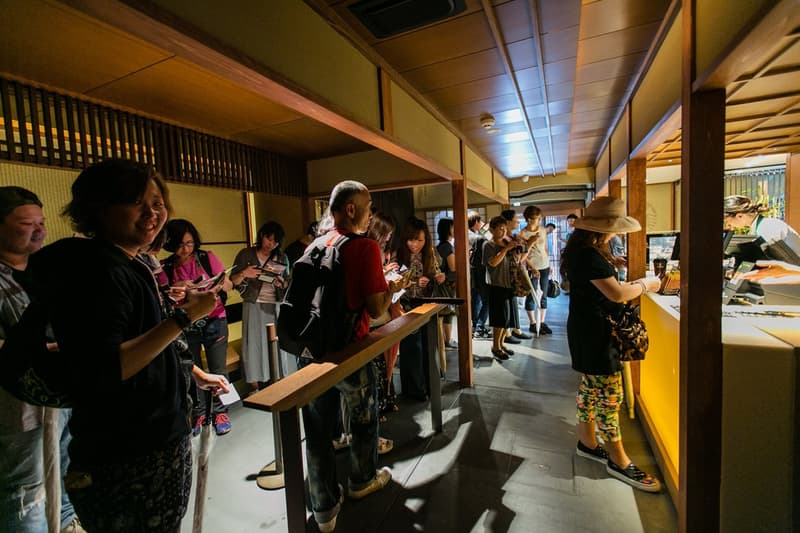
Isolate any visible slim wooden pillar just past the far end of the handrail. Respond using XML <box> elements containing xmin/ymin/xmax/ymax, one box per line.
<box><xmin>452</xmin><ymin>179</ymin><xmax>474</xmax><ymax>387</ymax></box>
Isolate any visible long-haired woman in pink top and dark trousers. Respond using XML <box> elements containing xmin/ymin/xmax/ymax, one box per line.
<box><xmin>159</xmin><ymin>218</ymin><xmax>232</xmax><ymax>435</ymax></box>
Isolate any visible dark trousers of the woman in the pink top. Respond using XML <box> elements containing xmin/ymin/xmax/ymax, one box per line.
<box><xmin>186</xmin><ymin>318</ymin><xmax>228</xmax><ymax>419</ymax></box>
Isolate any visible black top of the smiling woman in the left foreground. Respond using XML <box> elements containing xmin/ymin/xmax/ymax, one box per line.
<box><xmin>29</xmin><ymin>238</ymin><xmax>190</xmax><ymax>465</ymax></box>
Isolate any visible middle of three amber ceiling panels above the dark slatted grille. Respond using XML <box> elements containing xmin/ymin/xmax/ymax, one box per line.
<box><xmin>90</xmin><ymin>59</ymin><xmax>299</xmax><ymax>137</ymax></box>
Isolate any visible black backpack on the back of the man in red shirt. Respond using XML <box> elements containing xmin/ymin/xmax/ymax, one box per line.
<box><xmin>277</xmin><ymin>233</ymin><xmax>362</xmax><ymax>359</ymax></box>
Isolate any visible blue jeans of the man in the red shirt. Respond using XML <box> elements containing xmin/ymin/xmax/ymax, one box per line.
<box><xmin>297</xmin><ymin>359</ymin><xmax>378</xmax><ymax>523</ymax></box>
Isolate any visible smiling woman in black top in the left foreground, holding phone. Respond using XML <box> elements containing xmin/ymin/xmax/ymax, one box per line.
<box><xmin>29</xmin><ymin>159</ymin><xmax>228</xmax><ymax>532</ymax></box>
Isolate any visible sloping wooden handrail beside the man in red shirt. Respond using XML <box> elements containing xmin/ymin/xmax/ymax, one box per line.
<box><xmin>244</xmin><ymin>304</ymin><xmax>445</xmax><ymax>413</ymax></box>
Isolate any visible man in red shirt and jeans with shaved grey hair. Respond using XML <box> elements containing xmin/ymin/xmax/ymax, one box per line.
<box><xmin>300</xmin><ymin>181</ymin><xmax>402</xmax><ymax>532</ymax></box>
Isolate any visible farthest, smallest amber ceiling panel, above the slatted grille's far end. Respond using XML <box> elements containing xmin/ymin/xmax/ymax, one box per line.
<box><xmin>232</xmin><ymin>118</ymin><xmax>372</xmax><ymax>159</ymax></box>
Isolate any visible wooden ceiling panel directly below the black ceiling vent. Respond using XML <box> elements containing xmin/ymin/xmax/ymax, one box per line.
<box><xmin>375</xmin><ymin>12</ymin><xmax>494</xmax><ymax>72</ymax></box>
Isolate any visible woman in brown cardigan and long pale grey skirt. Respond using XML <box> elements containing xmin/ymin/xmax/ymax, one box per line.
<box><xmin>231</xmin><ymin>220</ymin><xmax>289</xmax><ymax>391</ymax></box>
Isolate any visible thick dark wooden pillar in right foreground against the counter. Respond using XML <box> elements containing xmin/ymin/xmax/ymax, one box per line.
<box><xmin>678</xmin><ymin>0</ymin><xmax>725</xmax><ymax>533</ymax></box>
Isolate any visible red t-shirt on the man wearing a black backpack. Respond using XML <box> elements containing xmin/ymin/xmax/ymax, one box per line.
<box><xmin>334</xmin><ymin>230</ymin><xmax>389</xmax><ymax>340</ymax></box>
